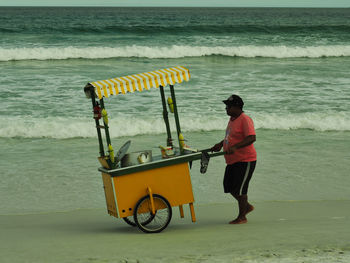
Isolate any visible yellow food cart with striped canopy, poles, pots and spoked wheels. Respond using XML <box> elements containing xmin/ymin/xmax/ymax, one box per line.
<box><xmin>84</xmin><ymin>66</ymin><xmax>223</xmax><ymax>233</ymax></box>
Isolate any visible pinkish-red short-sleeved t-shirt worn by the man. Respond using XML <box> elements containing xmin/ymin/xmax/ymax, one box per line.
<box><xmin>223</xmin><ymin>112</ymin><xmax>256</xmax><ymax>164</ymax></box>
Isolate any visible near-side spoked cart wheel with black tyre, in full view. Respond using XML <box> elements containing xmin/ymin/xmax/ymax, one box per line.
<box><xmin>134</xmin><ymin>194</ymin><xmax>172</xmax><ymax>233</ymax></box>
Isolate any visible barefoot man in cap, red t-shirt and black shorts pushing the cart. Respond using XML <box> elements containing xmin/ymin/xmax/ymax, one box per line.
<box><xmin>211</xmin><ymin>94</ymin><xmax>256</xmax><ymax>224</ymax></box>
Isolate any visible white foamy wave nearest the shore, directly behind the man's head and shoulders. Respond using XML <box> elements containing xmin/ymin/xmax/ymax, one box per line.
<box><xmin>0</xmin><ymin>112</ymin><xmax>350</xmax><ymax>139</ymax></box>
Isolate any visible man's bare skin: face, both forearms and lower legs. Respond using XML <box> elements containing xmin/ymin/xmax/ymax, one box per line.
<box><xmin>211</xmin><ymin>105</ymin><xmax>256</xmax><ymax>224</ymax></box>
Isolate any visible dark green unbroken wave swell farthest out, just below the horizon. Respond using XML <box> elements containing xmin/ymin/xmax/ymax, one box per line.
<box><xmin>0</xmin><ymin>23</ymin><xmax>350</xmax><ymax>35</ymax></box>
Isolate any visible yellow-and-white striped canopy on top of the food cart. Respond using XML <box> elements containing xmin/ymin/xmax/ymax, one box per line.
<box><xmin>84</xmin><ymin>66</ymin><xmax>190</xmax><ymax>99</ymax></box>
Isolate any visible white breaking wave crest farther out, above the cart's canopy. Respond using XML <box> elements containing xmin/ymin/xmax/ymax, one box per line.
<box><xmin>0</xmin><ymin>45</ymin><xmax>350</xmax><ymax>61</ymax></box>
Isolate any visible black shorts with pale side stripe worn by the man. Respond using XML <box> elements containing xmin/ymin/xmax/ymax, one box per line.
<box><xmin>224</xmin><ymin>161</ymin><xmax>256</xmax><ymax>195</ymax></box>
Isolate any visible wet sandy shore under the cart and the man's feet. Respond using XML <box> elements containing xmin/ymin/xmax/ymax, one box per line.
<box><xmin>0</xmin><ymin>200</ymin><xmax>350</xmax><ymax>263</ymax></box>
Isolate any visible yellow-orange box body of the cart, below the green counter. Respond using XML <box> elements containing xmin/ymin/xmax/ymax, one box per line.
<box><xmin>102</xmin><ymin>163</ymin><xmax>195</xmax><ymax>222</ymax></box>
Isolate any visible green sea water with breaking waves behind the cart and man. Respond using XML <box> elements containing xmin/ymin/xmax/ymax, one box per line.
<box><xmin>0</xmin><ymin>7</ymin><xmax>350</xmax><ymax>214</ymax></box>
